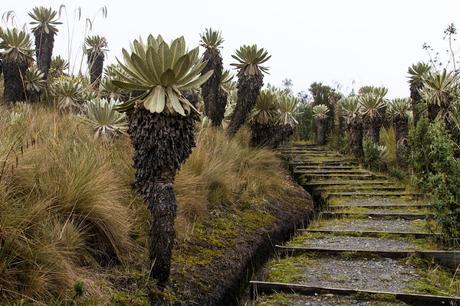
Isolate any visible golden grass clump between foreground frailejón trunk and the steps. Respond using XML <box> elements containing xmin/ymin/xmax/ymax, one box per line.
<box><xmin>175</xmin><ymin>128</ymin><xmax>288</xmax><ymax>238</ymax></box>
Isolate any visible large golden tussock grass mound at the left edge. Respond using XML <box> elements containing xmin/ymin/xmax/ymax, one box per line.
<box><xmin>0</xmin><ymin>106</ymin><xmax>130</xmax><ymax>301</ymax></box>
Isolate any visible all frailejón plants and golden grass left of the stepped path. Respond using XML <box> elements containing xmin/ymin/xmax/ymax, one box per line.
<box><xmin>0</xmin><ymin>6</ymin><xmax>310</xmax><ymax>305</ymax></box>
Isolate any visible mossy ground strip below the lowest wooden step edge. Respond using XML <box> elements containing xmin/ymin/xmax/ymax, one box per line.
<box><xmin>256</xmin><ymin>294</ymin><xmax>408</xmax><ymax>306</ymax></box>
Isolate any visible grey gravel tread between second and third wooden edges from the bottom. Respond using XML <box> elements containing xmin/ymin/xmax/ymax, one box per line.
<box><xmin>296</xmin><ymin>236</ymin><xmax>417</xmax><ymax>251</ymax></box>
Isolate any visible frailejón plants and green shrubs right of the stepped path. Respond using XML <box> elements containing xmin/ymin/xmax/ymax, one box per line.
<box><xmin>296</xmin><ymin>25</ymin><xmax>460</xmax><ymax>247</ymax></box>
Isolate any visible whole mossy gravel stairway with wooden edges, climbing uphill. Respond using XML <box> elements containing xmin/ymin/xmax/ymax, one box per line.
<box><xmin>251</xmin><ymin>144</ymin><xmax>460</xmax><ymax>305</ymax></box>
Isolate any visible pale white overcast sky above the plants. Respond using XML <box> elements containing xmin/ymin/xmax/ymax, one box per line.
<box><xmin>0</xmin><ymin>0</ymin><xmax>460</xmax><ymax>97</ymax></box>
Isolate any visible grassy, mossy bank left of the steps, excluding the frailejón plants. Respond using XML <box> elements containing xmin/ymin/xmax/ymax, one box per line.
<box><xmin>0</xmin><ymin>104</ymin><xmax>313</xmax><ymax>305</ymax></box>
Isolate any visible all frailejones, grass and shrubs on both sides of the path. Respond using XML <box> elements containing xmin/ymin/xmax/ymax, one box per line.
<box><xmin>0</xmin><ymin>6</ymin><xmax>460</xmax><ymax>305</ymax></box>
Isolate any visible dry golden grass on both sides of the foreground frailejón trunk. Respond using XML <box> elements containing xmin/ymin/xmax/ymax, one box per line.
<box><xmin>0</xmin><ymin>104</ymin><xmax>289</xmax><ymax>304</ymax></box>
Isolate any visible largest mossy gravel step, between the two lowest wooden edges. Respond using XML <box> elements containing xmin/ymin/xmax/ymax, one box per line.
<box><xmin>255</xmin><ymin>251</ymin><xmax>458</xmax><ymax>294</ymax></box>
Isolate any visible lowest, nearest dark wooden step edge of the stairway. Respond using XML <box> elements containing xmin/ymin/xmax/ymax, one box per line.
<box><xmin>250</xmin><ymin>281</ymin><xmax>460</xmax><ymax>305</ymax></box>
